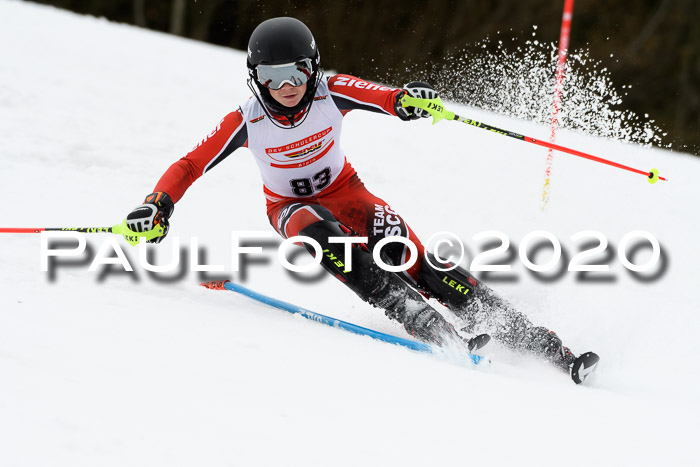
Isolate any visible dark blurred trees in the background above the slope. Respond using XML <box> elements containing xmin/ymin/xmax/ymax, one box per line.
<box><xmin>28</xmin><ymin>0</ymin><xmax>700</xmax><ymax>154</ymax></box>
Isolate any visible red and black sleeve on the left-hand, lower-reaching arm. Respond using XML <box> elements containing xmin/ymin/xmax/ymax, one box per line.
<box><xmin>153</xmin><ymin>110</ymin><xmax>248</xmax><ymax>203</ymax></box>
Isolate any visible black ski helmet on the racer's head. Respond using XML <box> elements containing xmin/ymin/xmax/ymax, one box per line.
<box><xmin>248</xmin><ymin>16</ymin><xmax>323</xmax><ymax>119</ymax></box>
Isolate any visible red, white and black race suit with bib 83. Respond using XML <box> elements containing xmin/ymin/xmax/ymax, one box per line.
<box><xmin>154</xmin><ymin>74</ymin><xmax>423</xmax><ymax>279</ymax></box>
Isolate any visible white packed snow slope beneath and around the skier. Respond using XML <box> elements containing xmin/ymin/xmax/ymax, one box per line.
<box><xmin>0</xmin><ymin>0</ymin><xmax>700</xmax><ymax>467</ymax></box>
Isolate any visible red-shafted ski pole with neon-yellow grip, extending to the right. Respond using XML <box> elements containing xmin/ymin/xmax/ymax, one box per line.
<box><xmin>401</xmin><ymin>96</ymin><xmax>666</xmax><ymax>184</ymax></box>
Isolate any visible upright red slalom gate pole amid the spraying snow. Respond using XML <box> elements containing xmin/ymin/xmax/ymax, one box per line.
<box><xmin>542</xmin><ymin>0</ymin><xmax>574</xmax><ymax>210</ymax></box>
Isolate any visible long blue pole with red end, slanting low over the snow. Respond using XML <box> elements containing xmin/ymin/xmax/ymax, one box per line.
<box><xmin>202</xmin><ymin>281</ymin><xmax>483</xmax><ymax>364</ymax></box>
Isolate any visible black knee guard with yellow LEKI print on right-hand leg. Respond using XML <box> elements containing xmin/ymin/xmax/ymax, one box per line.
<box><xmin>418</xmin><ymin>252</ymin><xmax>477</xmax><ymax>310</ymax></box>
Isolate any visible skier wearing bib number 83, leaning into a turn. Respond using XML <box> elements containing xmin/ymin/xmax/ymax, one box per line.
<box><xmin>127</xmin><ymin>17</ymin><xmax>575</xmax><ymax>371</ymax></box>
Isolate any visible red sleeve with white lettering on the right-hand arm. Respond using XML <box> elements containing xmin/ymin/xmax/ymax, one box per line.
<box><xmin>328</xmin><ymin>75</ymin><xmax>402</xmax><ymax>115</ymax></box>
